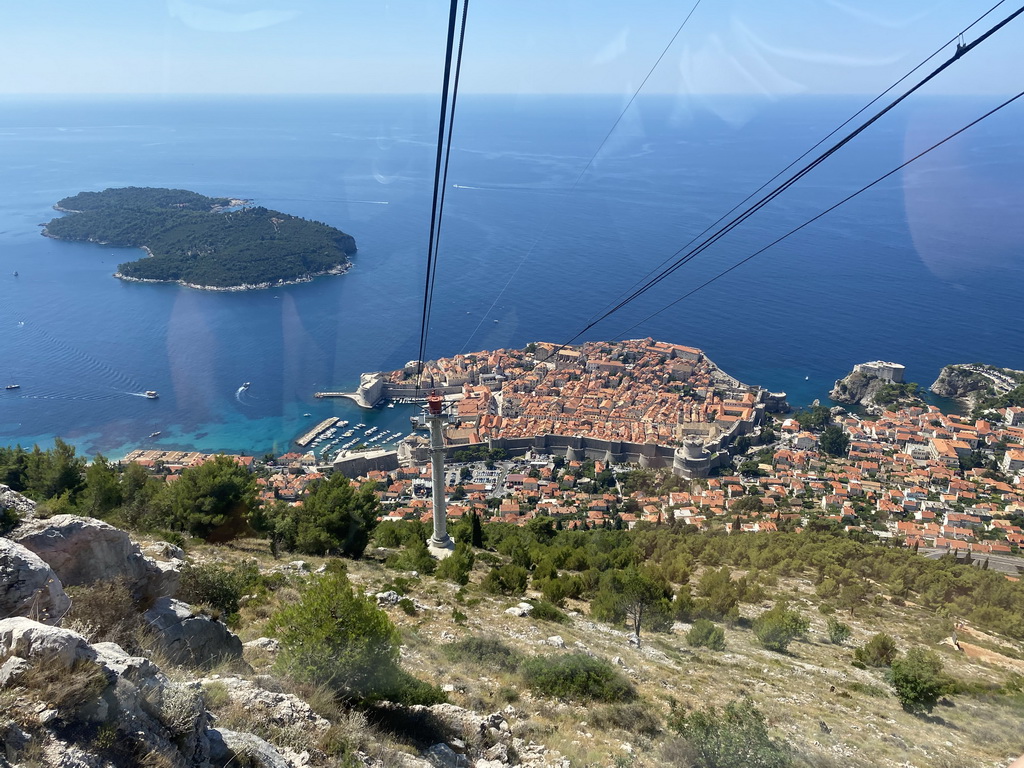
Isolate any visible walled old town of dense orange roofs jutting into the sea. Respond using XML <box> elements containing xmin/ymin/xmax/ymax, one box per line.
<box><xmin>344</xmin><ymin>338</ymin><xmax>788</xmax><ymax>477</ymax></box>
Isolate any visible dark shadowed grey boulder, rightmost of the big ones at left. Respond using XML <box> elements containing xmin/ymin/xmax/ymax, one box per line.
<box><xmin>142</xmin><ymin>597</ymin><xmax>242</xmax><ymax>667</ymax></box>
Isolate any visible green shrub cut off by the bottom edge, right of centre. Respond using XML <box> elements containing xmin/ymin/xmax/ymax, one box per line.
<box><xmin>669</xmin><ymin>699</ymin><xmax>793</xmax><ymax>768</ymax></box>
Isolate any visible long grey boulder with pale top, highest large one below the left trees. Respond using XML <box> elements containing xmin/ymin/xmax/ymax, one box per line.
<box><xmin>10</xmin><ymin>515</ymin><xmax>178</xmax><ymax>599</ymax></box>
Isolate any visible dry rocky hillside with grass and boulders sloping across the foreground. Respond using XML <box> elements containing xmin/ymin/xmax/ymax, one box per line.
<box><xmin>0</xmin><ymin>487</ymin><xmax>1024</xmax><ymax>768</ymax></box>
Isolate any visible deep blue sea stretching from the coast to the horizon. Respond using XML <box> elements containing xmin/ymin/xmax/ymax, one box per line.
<box><xmin>0</xmin><ymin>96</ymin><xmax>1024</xmax><ymax>457</ymax></box>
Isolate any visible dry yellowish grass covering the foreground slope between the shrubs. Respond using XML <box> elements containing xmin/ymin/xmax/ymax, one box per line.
<box><xmin>174</xmin><ymin>546</ymin><xmax>1024</xmax><ymax>768</ymax></box>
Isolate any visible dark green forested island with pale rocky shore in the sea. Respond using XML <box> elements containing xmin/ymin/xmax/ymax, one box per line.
<box><xmin>43</xmin><ymin>186</ymin><xmax>355</xmax><ymax>290</ymax></box>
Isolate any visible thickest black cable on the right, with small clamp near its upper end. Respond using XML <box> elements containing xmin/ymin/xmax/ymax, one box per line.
<box><xmin>561</xmin><ymin>6</ymin><xmax>1024</xmax><ymax>347</ymax></box>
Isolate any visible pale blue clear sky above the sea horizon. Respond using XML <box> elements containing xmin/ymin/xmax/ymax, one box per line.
<box><xmin>0</xmin><ymin>0</ymin><xmax>1024</xmax><ymax>95</ymax></box>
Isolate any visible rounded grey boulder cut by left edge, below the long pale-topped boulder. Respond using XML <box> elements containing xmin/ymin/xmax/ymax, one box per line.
<box><xmin>0</xmin><ymin>539</ymin><xmax>71</xmax><ymax>624</ymax></box>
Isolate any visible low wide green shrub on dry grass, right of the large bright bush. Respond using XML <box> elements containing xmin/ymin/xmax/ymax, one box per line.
<box><xmin>522</xmin><ymin>653</ymin><xmax>636</xmax><ymax>701</ymax></box>
